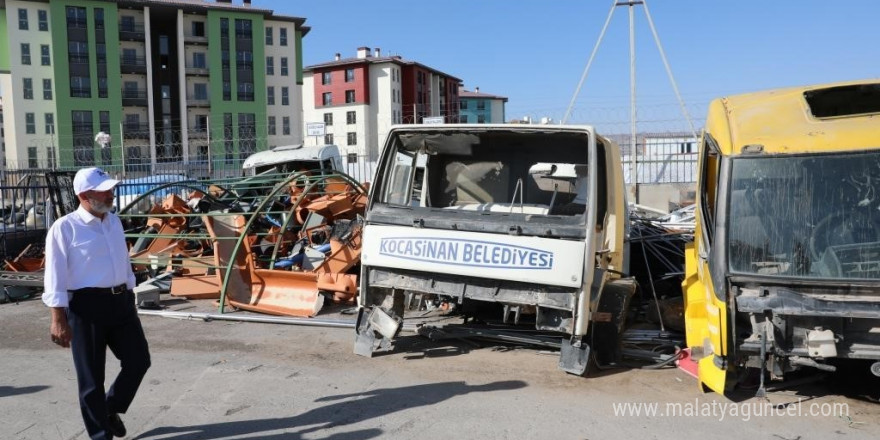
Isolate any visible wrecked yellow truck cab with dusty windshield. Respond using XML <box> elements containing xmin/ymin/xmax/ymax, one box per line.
<box><xmin>682</xmin><ymin>79</ymin><xmax>880</xmax><ymax>394</ymax></box>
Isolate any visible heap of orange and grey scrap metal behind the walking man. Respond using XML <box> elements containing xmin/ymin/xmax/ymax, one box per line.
<box><xmin>119</xmin><ymin>170</ymin><xmax>367</xmax><ymax>317</ymax></box>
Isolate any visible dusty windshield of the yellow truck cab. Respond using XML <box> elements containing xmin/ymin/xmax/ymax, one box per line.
<box><xmin>728</xmin><ymin>152</ymin><xmax>880</xmax><ymax>279</ymax></box>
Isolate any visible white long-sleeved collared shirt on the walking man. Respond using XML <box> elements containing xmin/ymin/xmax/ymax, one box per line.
<box><xmin>43</xmin><ymin>206</ymin><xmax>135</xmax><ymax>307</ymax></box>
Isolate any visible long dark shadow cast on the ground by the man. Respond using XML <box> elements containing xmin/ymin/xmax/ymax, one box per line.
<box><xmin>135</xmin><ymin>380</ymin><xmax>527</xmax><ymax>440</ymax></box>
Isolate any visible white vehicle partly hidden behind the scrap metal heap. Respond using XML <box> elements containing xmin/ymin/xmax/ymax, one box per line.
<box><xmin>242</xmin><ymin>144</ymin><xmax>343</xmax><ymax>176</ymax></box>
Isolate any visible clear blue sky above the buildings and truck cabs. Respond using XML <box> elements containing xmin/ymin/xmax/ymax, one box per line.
<box><xmin>254</xmin><ymin>0</ymin><xmax>880</xmax><ymax>132</ymax></box>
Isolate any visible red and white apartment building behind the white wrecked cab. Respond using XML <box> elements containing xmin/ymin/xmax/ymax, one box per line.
<box><xmin>303</xmin><ymin>47</ymin><xmax>461</xmax><ymax>160</ymax></box>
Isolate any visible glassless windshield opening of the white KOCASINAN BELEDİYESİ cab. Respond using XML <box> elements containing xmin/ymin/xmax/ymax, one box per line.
<box><xmin>380</xmin><ymin>131</ymin><xmax>589</xmax><ymax>220</ymax></box>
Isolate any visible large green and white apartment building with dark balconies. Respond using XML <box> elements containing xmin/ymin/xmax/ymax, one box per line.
<box><xmin>0</xmin><ymin>0</ymin><xmax>309</xmax><ymax>171</ymax></box>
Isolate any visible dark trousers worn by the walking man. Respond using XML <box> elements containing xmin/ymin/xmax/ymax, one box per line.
<box><xmin>67</xmin><ymin>290</ymin><xmax>150</xmax><ymax>440</ymax></box>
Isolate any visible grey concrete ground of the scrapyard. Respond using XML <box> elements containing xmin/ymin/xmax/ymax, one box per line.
<box><xmin>0</xmin><ymin>300</ymin><xmax>880</xmax><ymax>440</ymax></box>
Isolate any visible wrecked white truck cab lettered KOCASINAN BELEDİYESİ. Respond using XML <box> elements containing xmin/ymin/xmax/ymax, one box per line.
<box><xmin>355</xmin><ymin>124</ymin><xmax>635</xmax><ymax>374</ymax></box>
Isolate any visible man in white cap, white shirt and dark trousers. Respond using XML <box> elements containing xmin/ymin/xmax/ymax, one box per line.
<box><xmin>43</xmin><ymin>168</ymin><xmax>150</xmax><ymax>440</ymax></box>
